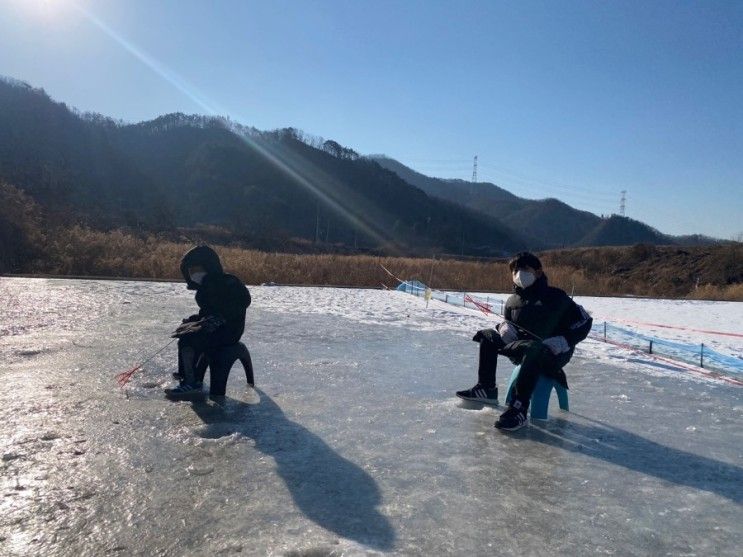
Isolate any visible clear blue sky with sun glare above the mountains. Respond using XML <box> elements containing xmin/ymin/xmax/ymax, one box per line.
<box><xmin>0</xmin><ymin>0</ymin><xmax>743</xmax><ymax>238</ymax></box>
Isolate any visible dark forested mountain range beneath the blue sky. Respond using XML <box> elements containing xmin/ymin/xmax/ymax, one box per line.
<box><xmin>0</xmin><ymin>78</ymin><xmax>713</xmax><ymax>256</ymax></box>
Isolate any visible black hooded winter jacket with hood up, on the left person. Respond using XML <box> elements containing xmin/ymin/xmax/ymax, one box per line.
<box><xmin>181</xmin><ymin>246</ymin><xmax>251</xmax><ymax>346</ymax></box>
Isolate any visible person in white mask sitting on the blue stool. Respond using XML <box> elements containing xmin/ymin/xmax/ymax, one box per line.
<box><xmin>457</xmin><ymin>252</ymin><xmax>593</xmax><ymax>431</ymax></box>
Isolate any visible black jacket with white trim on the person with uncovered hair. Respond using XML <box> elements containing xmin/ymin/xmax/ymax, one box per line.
<box><xmin>503</xmin><ymin>275</ymin><xmax>593</xmax><ymax>354</ymax></box>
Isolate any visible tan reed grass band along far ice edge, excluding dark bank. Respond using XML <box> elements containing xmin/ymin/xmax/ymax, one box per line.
<box><xmin>30</xmin><ymin>226</ymin><xmax>743</xmax><ymax>301</ymax></box>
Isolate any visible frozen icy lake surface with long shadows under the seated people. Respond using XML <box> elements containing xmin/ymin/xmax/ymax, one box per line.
<box><xmin>0</xmin><ymin>278</ymin><xmax>743</xmax><ymax>556</ymax></box>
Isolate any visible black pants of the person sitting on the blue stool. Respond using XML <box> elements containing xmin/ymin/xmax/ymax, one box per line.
<box><xmin>477</xmin><ymin>334</ymin><xmax>573</xmax><ymax>408</ymax></box>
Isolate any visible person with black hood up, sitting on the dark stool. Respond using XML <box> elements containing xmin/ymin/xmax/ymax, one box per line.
<box><xmin>165</xmin><ymin>246</ymin><xmax>250</xmax><ymax>398</ymax></box>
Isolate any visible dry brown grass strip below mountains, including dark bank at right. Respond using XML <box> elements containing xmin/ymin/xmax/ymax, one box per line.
<box><xmin>16</xmin><ymin>227</ymin><xmax>743</xmax><ymax>301</ymax></box>
